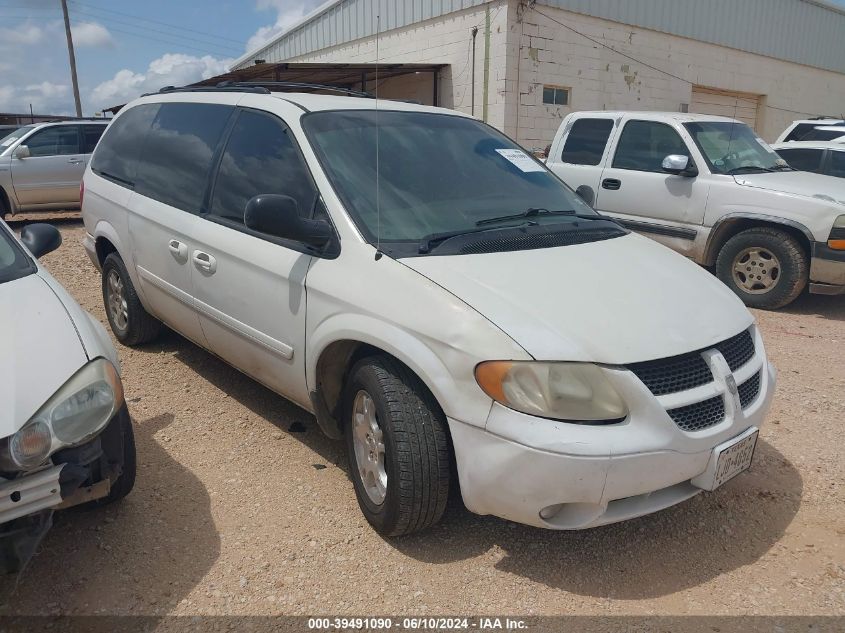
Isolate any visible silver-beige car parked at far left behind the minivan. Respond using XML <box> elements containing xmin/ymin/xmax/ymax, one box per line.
<box><xmin>0</xmin><ymin>120</ymin><xmax>108</xmax><ymax>218</ymax></box>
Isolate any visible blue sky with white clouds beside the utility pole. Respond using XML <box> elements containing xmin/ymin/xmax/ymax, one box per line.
<box><xmin>0</xmin><ymin>0</ymin><xmax>845</xmax><ymax>115</ymax></box>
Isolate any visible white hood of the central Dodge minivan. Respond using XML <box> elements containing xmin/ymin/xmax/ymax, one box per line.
<box><xmin>401</xmin><ymin>235</ymin><xmax>753</xmax><ymax>364</ymax></box>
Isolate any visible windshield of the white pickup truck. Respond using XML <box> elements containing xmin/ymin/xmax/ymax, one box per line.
<box><xmin>684</xmin><ymin>121</ymin><xmax>789</xmax><ymax>174</ymax></box>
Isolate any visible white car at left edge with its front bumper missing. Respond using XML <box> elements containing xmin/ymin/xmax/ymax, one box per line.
<box><xmin>0</xmin><ymin>220</ymin><xmax>135</xmax><ymax>573</ymax></box>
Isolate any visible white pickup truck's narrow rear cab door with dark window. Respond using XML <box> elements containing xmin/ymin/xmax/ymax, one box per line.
<box><xmin>546</xmin><ymin>115</ymin><xmax>615</xmax><ymax>200</ymax></box>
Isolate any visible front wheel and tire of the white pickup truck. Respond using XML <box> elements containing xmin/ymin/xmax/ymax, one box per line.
<box><xmin>716</xmin><ymin>227</ymin><xmax>809</xmax><ymax>310</ymax></box>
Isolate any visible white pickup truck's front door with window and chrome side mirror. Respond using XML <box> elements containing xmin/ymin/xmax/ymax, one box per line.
<box><xmin>595</xmin><ymin>119</ymin><xmax>709</xmax><ymax>243</ymax></box>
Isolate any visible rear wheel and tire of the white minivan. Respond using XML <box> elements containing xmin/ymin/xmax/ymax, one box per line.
<box><xmin>102</xmin><ymin>253</ymin><xmax>161</xmax><ymax>347</ymax></box>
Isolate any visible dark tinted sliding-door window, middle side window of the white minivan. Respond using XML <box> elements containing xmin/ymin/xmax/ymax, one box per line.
<box><xmin>135</xmin><ymin>103</ymin><xmax>233</xmax><ymax>213</ymax></box>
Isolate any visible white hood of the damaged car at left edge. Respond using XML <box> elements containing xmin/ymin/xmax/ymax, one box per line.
<box><xmin>0</xmin><ymin>274</ymin><xmax>88</xmax><ymax>437</ymax></box>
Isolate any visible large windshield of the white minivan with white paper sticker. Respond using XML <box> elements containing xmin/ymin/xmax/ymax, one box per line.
<box><xmin>302</xmin><ymin>110</ymin><xmax>601</xmax><ymax>252</ymax></box>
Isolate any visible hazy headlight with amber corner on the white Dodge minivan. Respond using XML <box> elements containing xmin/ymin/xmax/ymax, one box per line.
<box><xmin>475</xmin><ymin>361</ymin><xmax>628</xmax><ymax>424</ymax></box>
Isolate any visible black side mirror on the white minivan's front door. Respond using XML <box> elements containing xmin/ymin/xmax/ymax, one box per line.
<box><xmin>244</xmin><ymin>193</ymin><xmax>334</xmax><ymax>248</ymax></box>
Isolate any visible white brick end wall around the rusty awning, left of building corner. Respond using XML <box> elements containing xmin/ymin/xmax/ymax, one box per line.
<box><xmin>276</xmin><ymin>0</ymin><xmax>509</xmax><ymax>129</ymax></box>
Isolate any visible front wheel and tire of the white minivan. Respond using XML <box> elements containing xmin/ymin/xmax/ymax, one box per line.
<box><xmin>344</xmin><ymin>356</ymin><xmax>451</xmax><ymax>536</ymax></box>
